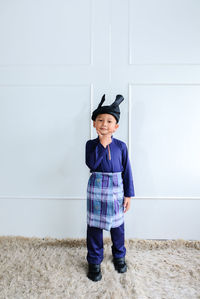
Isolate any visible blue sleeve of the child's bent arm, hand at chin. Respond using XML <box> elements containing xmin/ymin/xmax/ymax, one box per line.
<box><xmin>85</xmin><ymin>140</ymin><xmax>106</xmax><ymax>171</ymax></box>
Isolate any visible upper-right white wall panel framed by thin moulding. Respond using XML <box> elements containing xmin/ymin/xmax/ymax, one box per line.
<box><xmin>129</xmin><ymin>0</ymin><xmax>200</xmax><ymax>64</ymax></box>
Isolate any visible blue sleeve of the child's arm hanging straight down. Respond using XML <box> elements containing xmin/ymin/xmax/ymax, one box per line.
<box><xmin>122</xmin><ymin>143</ymin><xmax>135</xmax><ymax>197</ymax></box>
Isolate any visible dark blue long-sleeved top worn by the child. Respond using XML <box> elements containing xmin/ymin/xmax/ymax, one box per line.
<box><xmin>85</xmin><ymin>136</ymin><xmax>135</xmax><ymax>197</ymax></box>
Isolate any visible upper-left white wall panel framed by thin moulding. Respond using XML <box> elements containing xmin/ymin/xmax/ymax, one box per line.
<box><xmin>0</xmin><ymin>0</ymin><xmax>92</xmax><ymax>65</ymax></box>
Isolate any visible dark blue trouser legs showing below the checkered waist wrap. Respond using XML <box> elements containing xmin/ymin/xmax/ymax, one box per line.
<box><xmin>87</xmin><ymin>223</ymin><xmax>126</xmax><ymax>264</ymax></box>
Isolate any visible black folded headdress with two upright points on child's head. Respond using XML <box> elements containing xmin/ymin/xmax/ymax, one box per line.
<box><xmin>92</xmin><ymin>94</ymin><xmax>124</xmax><ymax>123</ymax></box>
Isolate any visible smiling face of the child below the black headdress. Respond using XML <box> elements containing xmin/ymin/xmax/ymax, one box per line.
<box><xmin>93</xmin><ymin>113</ymin><xmax>119</xmax><ymax>135</ymax></box>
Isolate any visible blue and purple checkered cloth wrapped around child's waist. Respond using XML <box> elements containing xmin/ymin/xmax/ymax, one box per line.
<box><xmin>87</xmin><ymin>172</ymin><xmax>124</xmax><ymax>230</ymax></box>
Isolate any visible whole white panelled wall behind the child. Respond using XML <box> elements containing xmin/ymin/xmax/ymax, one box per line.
<box><xmin>0</xmin><ymin>0</ymin><xmax>200</xmax><ymax>239</ymax></box>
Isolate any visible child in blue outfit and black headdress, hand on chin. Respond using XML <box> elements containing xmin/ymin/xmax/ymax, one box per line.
<box><xmin>85</xmin><ymin>95</ymin><xmax>135</xmax><ymax>281</ymax></box>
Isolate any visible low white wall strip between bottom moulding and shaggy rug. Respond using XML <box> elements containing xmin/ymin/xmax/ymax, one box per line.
<box><xmin>0</xmin><ymin>198</ymin><xmax>200</xmax><ymax>240</ymax></box>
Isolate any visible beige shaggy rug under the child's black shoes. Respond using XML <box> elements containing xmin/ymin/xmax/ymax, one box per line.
<box><xmin>0</xmin><ymin>237</ymin><xmax>200</xmax><ymax>299</ymax></box>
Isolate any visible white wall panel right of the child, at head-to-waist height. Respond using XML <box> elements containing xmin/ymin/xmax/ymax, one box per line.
<box><xmin>129</xmin><ymin>85</ymin><xmax>200</xmax><ymax>197</ymax></box>
